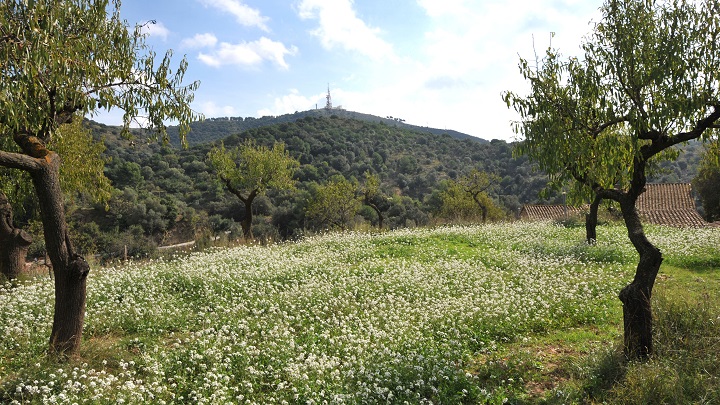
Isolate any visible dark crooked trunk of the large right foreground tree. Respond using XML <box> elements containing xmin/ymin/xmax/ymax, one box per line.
<box><xmin>620</xmin><ymin>196</ymin><xmax>663</xmax><ymax>359</ymax></box>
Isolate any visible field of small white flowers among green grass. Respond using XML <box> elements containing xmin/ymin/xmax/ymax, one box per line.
<box><xmin>0</xmin><ymin>223</ymin><xmax>720</xmax><ymax>404</ymax></box>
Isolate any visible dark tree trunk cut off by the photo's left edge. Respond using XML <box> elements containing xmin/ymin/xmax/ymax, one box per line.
<box><xmin>0</xmin><ymin>192</ymin><xmax>32</xmax><ymax>280</ymax></box>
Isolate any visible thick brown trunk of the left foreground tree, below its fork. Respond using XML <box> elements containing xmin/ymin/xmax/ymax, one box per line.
<box><xmin>30</xmin><ymin>152</ymin><xmax>90</xmax><ymax>356</ymax></box>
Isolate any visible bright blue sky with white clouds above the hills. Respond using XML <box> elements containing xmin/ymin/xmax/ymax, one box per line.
<box><xmin>94</xmin><ymin>0</ymin><xmax>602</xmax><ymax>141</ymax></box>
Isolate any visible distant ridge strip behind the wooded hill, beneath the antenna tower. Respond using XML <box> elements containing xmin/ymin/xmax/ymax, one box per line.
<box><xmin>168</xmin><ymin>108</ymin><xmax>487</xmax><ymax>146</ymax></box>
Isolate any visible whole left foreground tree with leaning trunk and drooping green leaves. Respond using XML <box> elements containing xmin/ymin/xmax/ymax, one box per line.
<box><xmin>0</xmin><ymin>0</ymin><xmax>199</xmax><ymax>355</ymax></box>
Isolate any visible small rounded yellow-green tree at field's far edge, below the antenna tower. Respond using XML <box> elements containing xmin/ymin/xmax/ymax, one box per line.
<box><xmin>307</xmin><ymin>176</ymin><xmax>360</xmax><ymax>230</ymax></box>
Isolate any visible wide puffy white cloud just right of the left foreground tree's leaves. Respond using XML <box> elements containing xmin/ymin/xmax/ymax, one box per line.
<box><xmin>198</xmin><ymin>37</ymin><xmax>297</xmax><ymax>70</ymax></box>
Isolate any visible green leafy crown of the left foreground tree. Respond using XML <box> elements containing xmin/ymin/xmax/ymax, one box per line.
<box><xmin>0</xmin><ymin>0</ymin><xmax>201</xmax><ymax>145</ymax></box>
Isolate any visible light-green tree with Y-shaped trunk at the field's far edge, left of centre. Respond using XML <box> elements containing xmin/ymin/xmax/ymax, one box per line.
<box><xmin>207</xmin><ymin>139</ymin><xmax>300</xmax><ymax>238</ymax></box>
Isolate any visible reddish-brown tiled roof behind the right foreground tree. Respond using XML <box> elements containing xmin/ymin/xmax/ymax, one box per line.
<box><xmin>520</xmin><ymin>183</ymin><xmax>708</xmax><ymax>227</ymax></box>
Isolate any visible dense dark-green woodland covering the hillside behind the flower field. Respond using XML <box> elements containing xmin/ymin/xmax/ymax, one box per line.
<box><xmin>2</xmin><ymin>113</ymin><xmax>702</xmax><ymax>260</ymax></box>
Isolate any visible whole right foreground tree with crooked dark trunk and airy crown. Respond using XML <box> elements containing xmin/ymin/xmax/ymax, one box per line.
<box><xmin>504</xmin><ymin>0</ymin><xmax>720</xmax><ymax>359</ymax></box>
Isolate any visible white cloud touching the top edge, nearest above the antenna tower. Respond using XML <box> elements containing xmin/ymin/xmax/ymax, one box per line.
<box><xmin>298</xmin><ymin>0</ymin><xmax>394</xmax><ymax>59</ymax></box>
